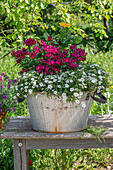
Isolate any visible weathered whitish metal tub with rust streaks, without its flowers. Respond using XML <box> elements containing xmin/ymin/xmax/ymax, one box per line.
<box><xmin>27</xmin><ymin>93</ymin><xmax>92</xmax><ymax>133</ymax></box>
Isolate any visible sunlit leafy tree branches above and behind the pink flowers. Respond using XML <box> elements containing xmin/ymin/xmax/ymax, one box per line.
<box><xmin>0</xmin><ymin>0</ymin><xmax>113</xmax><ymax>51</ymax></box>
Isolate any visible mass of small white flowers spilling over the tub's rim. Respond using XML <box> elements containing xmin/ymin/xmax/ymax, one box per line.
<box><xmin>15</xmin><ymin>64</ymin><xmax>109</xmax><ymax>107</ymax></box>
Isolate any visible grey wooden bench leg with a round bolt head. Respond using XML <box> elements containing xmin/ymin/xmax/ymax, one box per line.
<box><xmin>13</xmin><ymin>139</ymin><xmax>30</xmax><ymax>170</ymax></box>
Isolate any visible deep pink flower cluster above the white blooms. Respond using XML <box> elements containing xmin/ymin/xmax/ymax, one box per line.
<box><xmin>12</xmin><ymin>37</ymin><xmax>87</xmax><ymax>74</ymax></box>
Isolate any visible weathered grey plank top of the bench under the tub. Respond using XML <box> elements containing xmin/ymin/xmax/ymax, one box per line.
<box><xmin>0</xmin><ymin>115</ymin><xmax>113</xmax><ymax>139</ymax></box>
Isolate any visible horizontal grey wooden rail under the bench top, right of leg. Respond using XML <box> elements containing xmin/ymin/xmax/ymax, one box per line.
<box><xmin>26</xmin><ymin>138</ymin><xmax>113</xmax><ymax>149</ymax></box>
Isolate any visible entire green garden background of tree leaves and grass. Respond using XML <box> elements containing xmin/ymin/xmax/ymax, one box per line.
<box><xmin>0</xmin><ymin>0</ymin><xmax>113</xmax><ymax>170</ymax></box>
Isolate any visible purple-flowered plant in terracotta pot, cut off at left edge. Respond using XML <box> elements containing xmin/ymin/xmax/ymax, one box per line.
<box><xmin>0</xmin><ymin>72</ymin><xmax>17</xmax><ymax>129</ymax></box>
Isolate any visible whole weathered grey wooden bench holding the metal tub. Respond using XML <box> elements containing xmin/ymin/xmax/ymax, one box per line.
<box><xmin>0</xmin><ymin>115</ymin><xmax>113</xmax><ymax>170</ymax></box>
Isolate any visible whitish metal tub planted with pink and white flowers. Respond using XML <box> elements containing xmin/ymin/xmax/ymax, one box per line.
<box><xmin>12</xmin><ymin>23</ymin><xmax>109</xmax><ymax>133</ymax></box>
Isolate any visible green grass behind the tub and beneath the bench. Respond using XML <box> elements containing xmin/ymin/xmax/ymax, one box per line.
<box><xmin>0</xmin><ymin>45</ymin><xmax>113</xmax><ymax>170</ymax></box>
